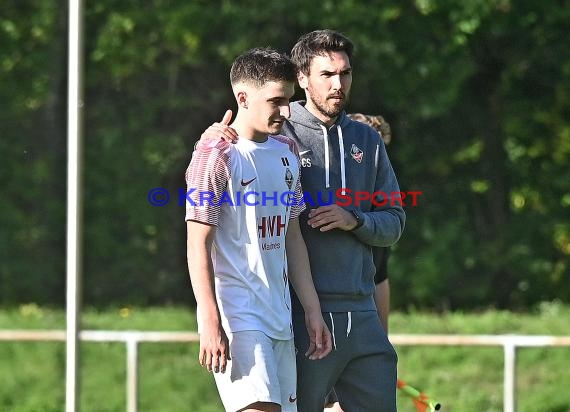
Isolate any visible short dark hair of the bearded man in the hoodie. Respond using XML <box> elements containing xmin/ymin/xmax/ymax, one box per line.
<box><xmin>291</xmin><ymin>29</ymin><xmax>354</xmax><ymax>74</ymax></box>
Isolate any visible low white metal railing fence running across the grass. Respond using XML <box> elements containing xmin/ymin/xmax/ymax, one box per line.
<box><xmin>0</xmin><ymin>330</ymin><xmax>570</xmax><ymax>412</ymax></box>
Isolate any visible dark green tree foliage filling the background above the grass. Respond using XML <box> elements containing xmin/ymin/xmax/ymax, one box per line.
<box><xmin>0</xmin><ymin>0</ymin><xmax>570</xmax><ymax>309</ymax></box>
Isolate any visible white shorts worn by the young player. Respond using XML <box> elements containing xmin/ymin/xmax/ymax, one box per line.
<box><xmin>214</xmin><ymin>330</ymin><xmax>297</xmax><ymax>412</ymax></box>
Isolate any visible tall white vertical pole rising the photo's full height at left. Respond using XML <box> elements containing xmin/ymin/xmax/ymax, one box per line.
<box><xmin>65</xmin><ymin>0</ymin><xmax>83</xmax><ymax>412</ymax></box>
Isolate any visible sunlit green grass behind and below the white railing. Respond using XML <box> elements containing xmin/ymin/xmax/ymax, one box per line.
<box><xmin>0</xmin><ymin>304</ymin><xmax>570</xmax><ymax>412</ymax></box>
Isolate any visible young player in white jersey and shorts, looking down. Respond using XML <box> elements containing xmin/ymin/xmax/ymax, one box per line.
<box><xmin>186</xmin><ymin>49</ymin><xmax>332</xmax><ymax>412</ymax></box>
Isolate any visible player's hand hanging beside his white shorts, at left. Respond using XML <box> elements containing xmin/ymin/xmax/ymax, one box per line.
<box><xmin>198</xmin><ymin>322</ymin><xmax>230</xmax><ymax>373</ymax></box>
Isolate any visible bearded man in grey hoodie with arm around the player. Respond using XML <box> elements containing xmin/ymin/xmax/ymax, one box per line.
<box><xmin>197</xmin><ymin>30</ymin><xmax>405</xmax><ymax>412</ymax></box>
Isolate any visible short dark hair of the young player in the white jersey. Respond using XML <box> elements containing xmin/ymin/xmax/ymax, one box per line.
<box><xmin>230</xmin><ymin>47</ymin><xmax>297</xmax><ymax>87</ymax></box>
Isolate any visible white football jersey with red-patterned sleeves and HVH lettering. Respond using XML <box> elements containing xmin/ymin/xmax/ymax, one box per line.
<box><xmin>186</xmin><ymin>135</ymin><xmax>305</xmax><ymax>339</ymax></box>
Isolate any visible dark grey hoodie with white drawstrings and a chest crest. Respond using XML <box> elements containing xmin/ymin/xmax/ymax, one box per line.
<box><xmin>282</xmin><ymin>102</ymin><xmax>405</xmax><ymax>312</ymax></box>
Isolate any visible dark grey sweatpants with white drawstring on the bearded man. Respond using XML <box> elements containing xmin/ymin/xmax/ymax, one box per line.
<box><xmin>293</xmin><ymin>311</ymin><xmax>398</xmax><ymax>412</ymax></box>
